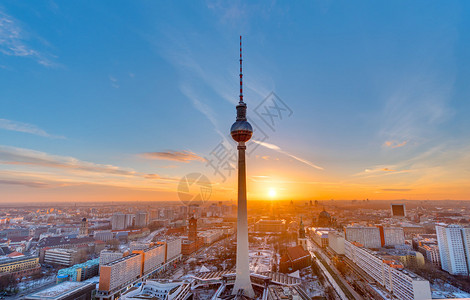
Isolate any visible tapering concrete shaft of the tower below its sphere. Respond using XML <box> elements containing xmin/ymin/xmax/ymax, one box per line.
<box><xmin>232</xmin><ymin>142</ymin><xmax>255</xmax><ymax>298</ymax></box>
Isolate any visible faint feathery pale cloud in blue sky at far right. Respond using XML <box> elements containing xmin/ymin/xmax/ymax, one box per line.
<box><xmin>378</xmin><ymin>43</ymin><xmax>457</xmax><ymax>148</ymax></box>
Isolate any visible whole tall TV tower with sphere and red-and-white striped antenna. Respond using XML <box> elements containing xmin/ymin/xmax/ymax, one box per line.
<box><xmin>230</xmin><ymin>36</ymin><xmax>255</xmax><ymax>298</ymax></box>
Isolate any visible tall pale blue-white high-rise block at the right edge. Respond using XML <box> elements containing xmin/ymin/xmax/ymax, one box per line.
<box><xmin>436</xmin><ymin>224</ymin><xmax>470</xmax><ymax>275</ymax></box>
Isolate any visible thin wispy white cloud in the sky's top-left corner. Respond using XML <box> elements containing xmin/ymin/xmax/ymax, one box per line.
<box><xmin>0</xmin><ymin>10</ymin><xmax>57</xmax><ymax>67</ymax></box>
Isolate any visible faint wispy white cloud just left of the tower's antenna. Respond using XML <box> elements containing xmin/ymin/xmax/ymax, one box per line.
<box><xmin>152</xmin><ymin>28</ymin><xmax>270</xmax><ymax>142</ymax></box>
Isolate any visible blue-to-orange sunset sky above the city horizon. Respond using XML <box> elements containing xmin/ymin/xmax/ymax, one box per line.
<box><xmin>0</xmin><ymin>0</ymin><xmax>470</xmax><ymax>203</ymax></box>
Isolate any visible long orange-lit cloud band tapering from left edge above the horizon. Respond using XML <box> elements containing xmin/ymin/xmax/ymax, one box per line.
<box><xmin>0</xmin><ymin>145</ymin><xmax>179</xmax><ymax>190</ymax></box>
